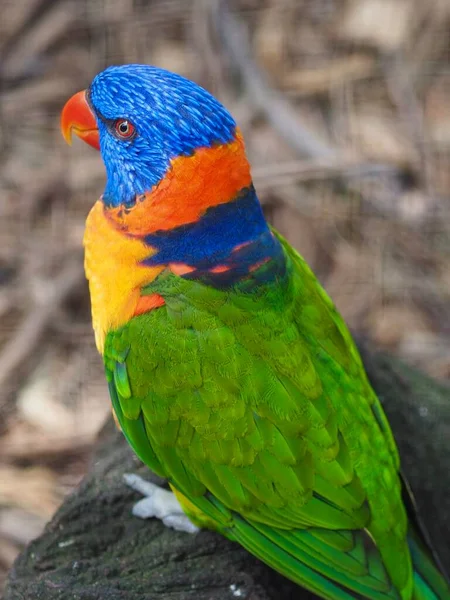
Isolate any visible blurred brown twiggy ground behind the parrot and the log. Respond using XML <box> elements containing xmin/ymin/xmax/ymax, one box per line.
<box><xmin>0</xmin><ymin>0</ymin><xmax>450</xmax><ymax>596</ymax></box>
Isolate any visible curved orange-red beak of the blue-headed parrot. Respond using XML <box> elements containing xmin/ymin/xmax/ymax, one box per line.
<box><xmin>61</xmin><ymin>90</ymin><xmax>100</xmax><ymax>150</ymax></box>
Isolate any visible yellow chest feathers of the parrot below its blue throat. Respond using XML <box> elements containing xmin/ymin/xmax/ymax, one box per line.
<box><xmin>84</xmin><ymin>200</ymin><xmax>164</xmax><ymax>353</ymax></box>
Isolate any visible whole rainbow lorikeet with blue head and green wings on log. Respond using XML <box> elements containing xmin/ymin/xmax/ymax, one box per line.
<box><xmin>62</xmin><ymin>65</ymin><xmax>450</xmax><ymax>600</ymax></box>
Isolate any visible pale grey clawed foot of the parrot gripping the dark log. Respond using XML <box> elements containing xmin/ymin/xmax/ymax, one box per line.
<box><xmin>123</xmin><ymin>473</ymin><xmax>199</xmax><ymax>533</ymax></box>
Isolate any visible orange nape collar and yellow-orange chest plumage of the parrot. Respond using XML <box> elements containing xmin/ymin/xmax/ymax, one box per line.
<box><xmin>84</xmin><ymin>131</ymin><xmax>251</xmax><ymax>352</ymax></box>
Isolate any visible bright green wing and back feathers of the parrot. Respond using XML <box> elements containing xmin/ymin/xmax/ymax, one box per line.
<box><xmin>104</xmin><ymin>233</ymin><xmax>413</xmax><ymax>600</ymax></box>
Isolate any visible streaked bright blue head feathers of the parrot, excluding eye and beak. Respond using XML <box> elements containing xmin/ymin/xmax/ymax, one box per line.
<box><xmin>89</xmin><ymin>65</ymin><xmax>236</xmax><ymax>206</ymax></box>
